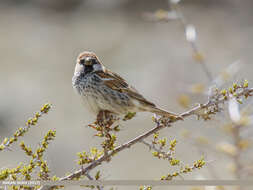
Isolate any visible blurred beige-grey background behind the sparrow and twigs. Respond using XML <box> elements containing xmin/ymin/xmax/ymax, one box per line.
<box><xmin>0</xmin><ymin>0</ymin><xmax>253</xmax><ymax>190</ymax></box>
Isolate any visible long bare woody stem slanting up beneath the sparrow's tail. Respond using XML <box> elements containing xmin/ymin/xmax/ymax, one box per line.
<box><xmin>40</xmin><ymin>88</ymin><xmax>253</xmax><ymax>190</ymax></box>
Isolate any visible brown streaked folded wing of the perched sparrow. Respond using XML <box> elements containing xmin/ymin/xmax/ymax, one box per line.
<box><xmin>96</xmin><ymin>70</ymin><xmax>155</xmax><ymax>107</ymax></box>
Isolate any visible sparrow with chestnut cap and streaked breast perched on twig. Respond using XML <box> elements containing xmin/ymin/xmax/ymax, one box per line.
<box><xmin>72</xmin><ymin>51</ymin><xmax>182</xmax><ymax>119</ymax></box>
